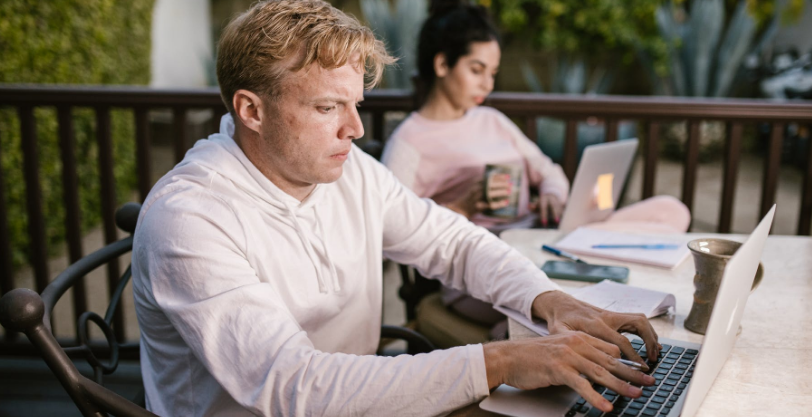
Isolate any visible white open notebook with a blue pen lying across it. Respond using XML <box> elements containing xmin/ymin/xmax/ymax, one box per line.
<box><xmin>555</xmin><ymin>227</ymin><xmax>691</xmax><ymax>269</ymax></box>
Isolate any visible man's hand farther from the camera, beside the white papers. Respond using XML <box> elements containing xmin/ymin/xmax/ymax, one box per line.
<box><xmin>533</xmin><ymin>291</ymin><xmax>662</xmax><ymax>369</ymax></box>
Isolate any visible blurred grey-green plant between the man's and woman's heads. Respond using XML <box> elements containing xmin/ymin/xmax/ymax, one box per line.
<box><xmin>361</xmin><ymin>0</ymin><xmax>427</xmax><ymax>89</ymax></box>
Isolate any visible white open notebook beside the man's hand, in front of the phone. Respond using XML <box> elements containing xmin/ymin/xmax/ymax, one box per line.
<box><xmin>494</xmin><ymin>279</ymin><xmax>677</xmax><ymax>336</ymax></box>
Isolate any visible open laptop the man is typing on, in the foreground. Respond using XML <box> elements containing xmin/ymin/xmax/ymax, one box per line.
<box><xmin>480</xmin><ymin>205</ymin><xmax>775</xmax><ymax>417</ymax></box>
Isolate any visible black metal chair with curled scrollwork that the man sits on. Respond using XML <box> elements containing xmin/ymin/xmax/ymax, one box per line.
<box><xmin>0</xmin><ymin>203</ymin><xmax>434</xmax><ymax>417</ymax></box>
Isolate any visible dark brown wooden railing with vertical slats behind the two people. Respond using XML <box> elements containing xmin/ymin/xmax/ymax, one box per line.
<box><xmin>0</xmin><ymin>86</ymin><xmax>812</xmax><ymax>350</ymax></box>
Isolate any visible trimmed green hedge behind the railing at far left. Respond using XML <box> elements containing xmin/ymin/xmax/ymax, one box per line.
<box><xmin>0</xmin><ymin>0</ymin><xmax>154</xmax><ymax>266</ymax></box>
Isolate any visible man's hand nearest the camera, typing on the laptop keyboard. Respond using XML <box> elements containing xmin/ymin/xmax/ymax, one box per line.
<box><xmin>483</xmin><ymin>332</ymin><xmax>654</xmax><ymax>411</ymax></box>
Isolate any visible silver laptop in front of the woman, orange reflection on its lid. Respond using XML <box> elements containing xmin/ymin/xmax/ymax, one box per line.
<box><xmin>558</xmin><ymin>139</ymin><xmax>637</xmax><ymax>233</ymax></box>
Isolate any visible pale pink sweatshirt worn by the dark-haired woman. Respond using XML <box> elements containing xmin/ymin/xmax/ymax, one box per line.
<box><xmin>382</xmin><ymin>107</ymin><xmax>569</xmax><ymax>227</ymax></box>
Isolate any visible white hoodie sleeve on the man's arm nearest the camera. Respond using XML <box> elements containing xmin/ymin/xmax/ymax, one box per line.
<box><xmin>134</xmin><ymin>192</ymin><xmax>488</xmax><ymax>416</ymax></box>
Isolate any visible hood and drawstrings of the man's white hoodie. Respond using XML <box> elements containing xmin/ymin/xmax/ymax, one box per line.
<box><xmin>178</xmin><ymin>114</ymin><xmax>341</xmax><ymax>293</ymax></box>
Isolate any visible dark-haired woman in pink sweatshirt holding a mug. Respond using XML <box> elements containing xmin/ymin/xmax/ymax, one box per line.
<box><xmin>382</xmin><ymin>1</ymin><xmax>690</xmax><ymax>330</ymax></box>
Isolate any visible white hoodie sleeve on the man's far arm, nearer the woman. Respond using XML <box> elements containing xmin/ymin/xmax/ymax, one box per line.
<box><xmin>369</xmin><ymin>153</ymin><xmax>560</xmax><ymax>318</ymax></box>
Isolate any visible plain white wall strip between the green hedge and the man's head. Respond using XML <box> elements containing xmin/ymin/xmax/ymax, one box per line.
<box><xmin>150</xmin><ymin>0</ymin><xmax>214</xmax><ymax>88</ymax></box>
